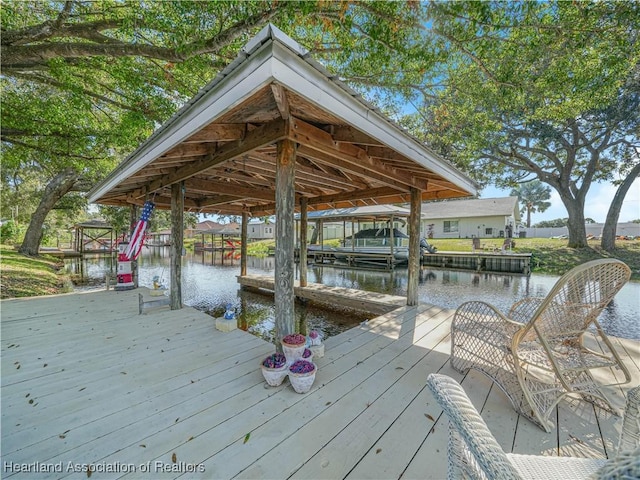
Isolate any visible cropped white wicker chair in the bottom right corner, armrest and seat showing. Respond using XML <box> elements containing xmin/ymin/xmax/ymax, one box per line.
<box><xmin>427</xmin><ymin>373</ymin><xmax>640</xmax><ymax>480</ymax></box>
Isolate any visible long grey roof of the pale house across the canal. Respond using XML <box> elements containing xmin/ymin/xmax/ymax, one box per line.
<box><xmin>422</xmin><ymin>197</ymin><xmax>520</xmax><ymax>221</ymax></box>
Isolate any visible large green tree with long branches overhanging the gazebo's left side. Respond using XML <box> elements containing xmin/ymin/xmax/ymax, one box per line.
<box><xmin>0</xmin><ymin>0</ymin><xmax>430</xmax><ymax>255</ymax></box>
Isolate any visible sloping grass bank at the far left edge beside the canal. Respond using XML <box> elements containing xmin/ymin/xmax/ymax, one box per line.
<box><xmin>0</xmin><ymin>245</ymin><xmax>72</xmax><ymax>298</ymax></box>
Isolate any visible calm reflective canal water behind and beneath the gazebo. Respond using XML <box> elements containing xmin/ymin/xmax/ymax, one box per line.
<box><xmin>67</xmin><ymin>248</ymin><xmax>640</xmax><ymax>341</ymax></box>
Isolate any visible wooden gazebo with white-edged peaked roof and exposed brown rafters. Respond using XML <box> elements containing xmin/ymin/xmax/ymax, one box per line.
<box><xmin>89</xmin><ymin>25</ymin><xmax>477</xmax><ymax>337</ymax></box>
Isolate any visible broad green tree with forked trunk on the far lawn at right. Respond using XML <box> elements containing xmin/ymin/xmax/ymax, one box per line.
<box><xmin>421</xmin><ymin>1</ymin><xmax>640</xmax><ymax>251</ymax></box>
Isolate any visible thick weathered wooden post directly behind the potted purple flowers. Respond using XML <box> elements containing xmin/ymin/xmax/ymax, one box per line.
<box><xmin>275</xmin><ymin>139</ymin><xmax>296</xmax><ymax>344</ymax></box>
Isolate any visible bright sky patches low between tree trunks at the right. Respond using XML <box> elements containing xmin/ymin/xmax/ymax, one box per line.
<box><xmin>480</xmin><ymin>179</ymin><xmax>640</xmax><ymax>225</ymax></box>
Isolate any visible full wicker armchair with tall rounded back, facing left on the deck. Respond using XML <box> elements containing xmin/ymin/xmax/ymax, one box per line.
<box><xmin>451</xmin><ymin>259</ymin><xmax>631</xmax><ymax>432</ymax></box>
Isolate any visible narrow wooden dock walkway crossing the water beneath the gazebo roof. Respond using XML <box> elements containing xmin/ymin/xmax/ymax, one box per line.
<box><xmin>238</xmin><ymin>275</ymin><xmax>407</xmax><ymax>315</ymax></box>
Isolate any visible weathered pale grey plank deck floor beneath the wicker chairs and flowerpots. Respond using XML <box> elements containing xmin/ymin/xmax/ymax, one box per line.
<box><xmin>0</xmin><ymin>290</ymin><xmax>640</xmax><ymax>479</ymax></box>
